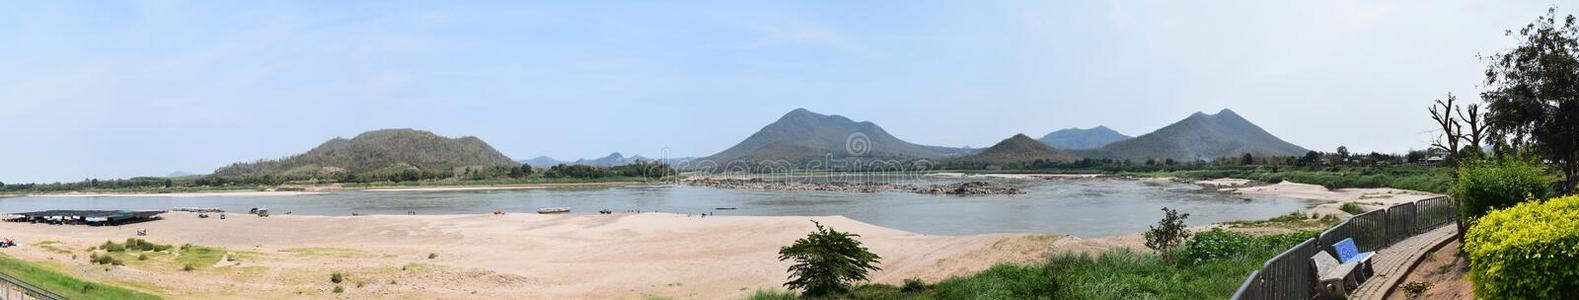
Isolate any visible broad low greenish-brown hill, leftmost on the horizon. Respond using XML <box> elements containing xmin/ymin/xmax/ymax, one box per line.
<box><xmin>215</xmin><ymin>129</ymin><xmax>516</xmax><ymax>177</ymax></box>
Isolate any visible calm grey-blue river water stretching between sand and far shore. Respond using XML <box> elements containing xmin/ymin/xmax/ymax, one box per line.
<box><xmin>0</xmin><ymin>180</ymin><xmax>1306</xmax><ymax>237</ymax></box>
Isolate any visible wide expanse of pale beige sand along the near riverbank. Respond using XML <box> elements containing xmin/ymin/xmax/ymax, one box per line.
<box><xmin>0</xmin><ymin>213</ymin><xmax>1058</xmax><ymax>298</ymax></box>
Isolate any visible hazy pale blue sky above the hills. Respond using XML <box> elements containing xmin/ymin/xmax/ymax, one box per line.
<box><xmin>0</xmin><ymin>0</ymin><xmax>1579</xmax><ymax>183</ymax></box>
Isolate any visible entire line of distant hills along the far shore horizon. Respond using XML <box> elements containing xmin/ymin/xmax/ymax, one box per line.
<box><xmin>213</xmin><ymin>109</ymin><xmax>1307</xmax><ymax>177</ymax></box>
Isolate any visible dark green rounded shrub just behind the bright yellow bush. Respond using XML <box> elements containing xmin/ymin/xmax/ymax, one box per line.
<box><xmin>1453</xmin><ymin>159</ymin><xmax>1551</xmax><ymax>224</ymax></box>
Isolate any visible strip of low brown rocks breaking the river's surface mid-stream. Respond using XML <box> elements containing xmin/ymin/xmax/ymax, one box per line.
<box><xmin>685</xmin><ymin>178</ymin><xmax>1025</xmax><ymax>196</ymax></box>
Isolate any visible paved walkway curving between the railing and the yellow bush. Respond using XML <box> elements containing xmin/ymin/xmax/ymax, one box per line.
<box><xmin>1348</xmin><ymin>223</ymin><xmax>1459</xmax><ymax>300</ymax></box>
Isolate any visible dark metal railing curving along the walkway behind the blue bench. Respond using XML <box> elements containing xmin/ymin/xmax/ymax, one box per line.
<box><xmin>1233</xmin><ymin>197</ymin><xmax>1457</xmax><ymax>300</ymax></box>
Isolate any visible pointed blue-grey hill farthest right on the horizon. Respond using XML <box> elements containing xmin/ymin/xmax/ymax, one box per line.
<box><xmin>1086</xmin><ymin>109</ymin><xmax>1307</xmax><ymax>161</ymax></box>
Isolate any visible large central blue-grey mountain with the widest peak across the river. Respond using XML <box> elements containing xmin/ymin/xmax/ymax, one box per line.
<box><xmin>706</xmin><ymin>109</ymin><xmax>968</xmax><ymax>164</ymax></box>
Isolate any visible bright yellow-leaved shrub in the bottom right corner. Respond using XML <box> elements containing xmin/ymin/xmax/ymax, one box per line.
<box><xmin>1464</xmin><ymin>196</ymin><xmax>1579</xmax><ymax>298</ymax></box>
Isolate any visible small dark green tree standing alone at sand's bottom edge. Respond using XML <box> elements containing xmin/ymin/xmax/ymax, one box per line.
<box><xmin>778</xmin><ymin>221</ymin><xmax>883</xmax><ymax>297</ymax></box>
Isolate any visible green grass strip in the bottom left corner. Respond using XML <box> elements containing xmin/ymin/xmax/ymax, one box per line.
<box><xmin>0</xmin><ymin>254</ymin><xmax>159</xmax><ymax>300</ymax></box>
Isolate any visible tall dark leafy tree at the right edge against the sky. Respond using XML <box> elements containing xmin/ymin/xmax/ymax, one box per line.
<box><xmin>1481</xmin><ymin>8</ymin><xmax>1579</xmax><ymax>193</ymax></box>
